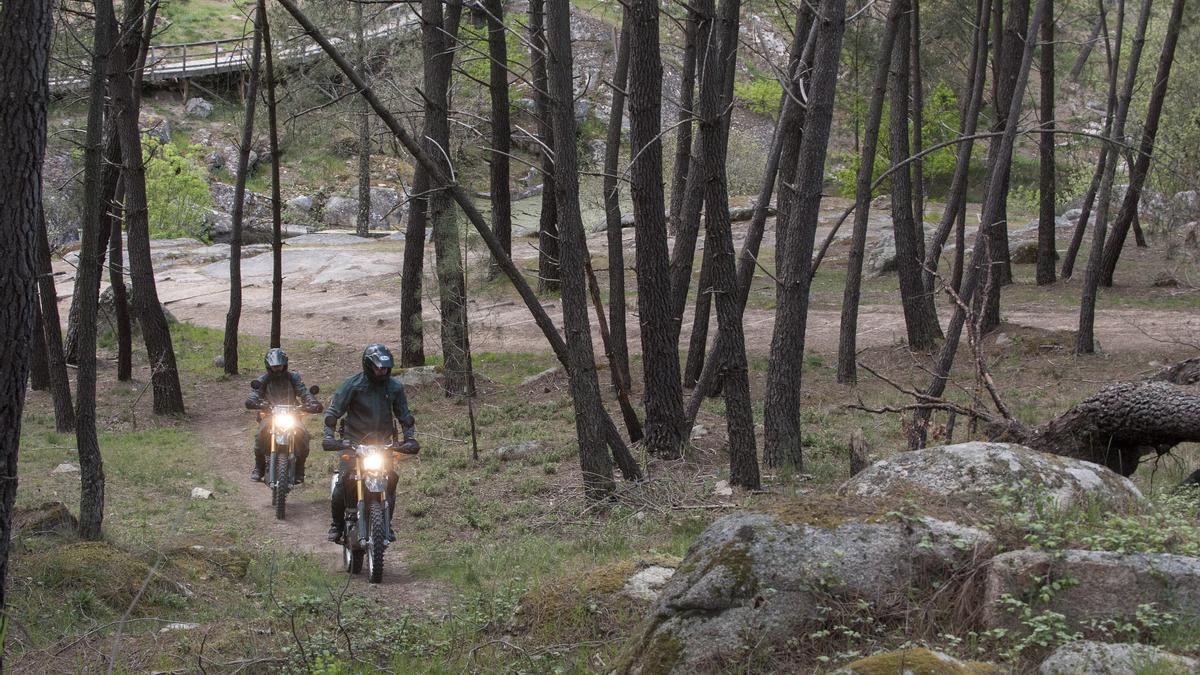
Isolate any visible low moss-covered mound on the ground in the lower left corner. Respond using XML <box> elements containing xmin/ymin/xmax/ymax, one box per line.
<box><xmin>28</xmin><ymin>542</ymin><xmax>180</xmax><ymax>611</ymax></box>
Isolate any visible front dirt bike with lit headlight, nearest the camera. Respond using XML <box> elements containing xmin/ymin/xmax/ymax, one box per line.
<box><xmin>325</xmin><ymin>440</ymin><xmax>420</xmax><ymax>584</ymax></box>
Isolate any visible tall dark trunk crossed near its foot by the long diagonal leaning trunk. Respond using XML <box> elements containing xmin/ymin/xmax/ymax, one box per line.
<box><xmin>546</xmin><ymin>0</ymin><xmax>614</xmax><ymax>498</ymax></box>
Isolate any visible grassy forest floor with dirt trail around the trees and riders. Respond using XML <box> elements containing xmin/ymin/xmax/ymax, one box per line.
<box><xmin>8</xmin><ymin>207</ymin><xmax>1200</xmax><ymax>671</ymax></box>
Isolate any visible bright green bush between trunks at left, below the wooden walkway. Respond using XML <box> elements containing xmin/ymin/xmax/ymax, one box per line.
<box><xmin>142</xmin><ymin>136</ymin><xmax>212</xmax><ymax>239</ymax></box>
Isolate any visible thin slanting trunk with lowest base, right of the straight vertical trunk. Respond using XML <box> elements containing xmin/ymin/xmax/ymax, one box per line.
<box><xmin>1075</xmin><ymin>0</ymin><xmax>1132</xmax><ymax>354</ymax></box>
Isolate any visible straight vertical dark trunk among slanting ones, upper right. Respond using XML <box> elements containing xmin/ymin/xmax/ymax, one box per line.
<box><xmin>1037</xmin><ymin>0</ymin><xmax>1058</xmax><ymax>286</ymax></box>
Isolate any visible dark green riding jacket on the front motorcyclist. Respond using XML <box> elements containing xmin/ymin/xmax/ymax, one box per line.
<box><xmin>325</xmin><ymin>372</ymin><xmax>416</xmax><ymax>443</ymax></box>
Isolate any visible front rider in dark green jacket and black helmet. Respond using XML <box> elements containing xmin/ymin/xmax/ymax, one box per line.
<box><xmin>324</xmin><ymin>344</ymin><xmax>420</xmax><ymax>542</ymax></box>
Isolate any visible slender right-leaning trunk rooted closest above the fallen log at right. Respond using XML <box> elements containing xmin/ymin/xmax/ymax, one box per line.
<box><xmin>1075</xmin><ymin>0</ymin><xmax>1153</xmax><ymax>345</ymax></box>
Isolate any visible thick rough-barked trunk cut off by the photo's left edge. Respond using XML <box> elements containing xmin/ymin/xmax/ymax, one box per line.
<box><xmin>0</xmin><ymin>0</ymin><xmax>54</xmax><ymax>643</ymax></box>
